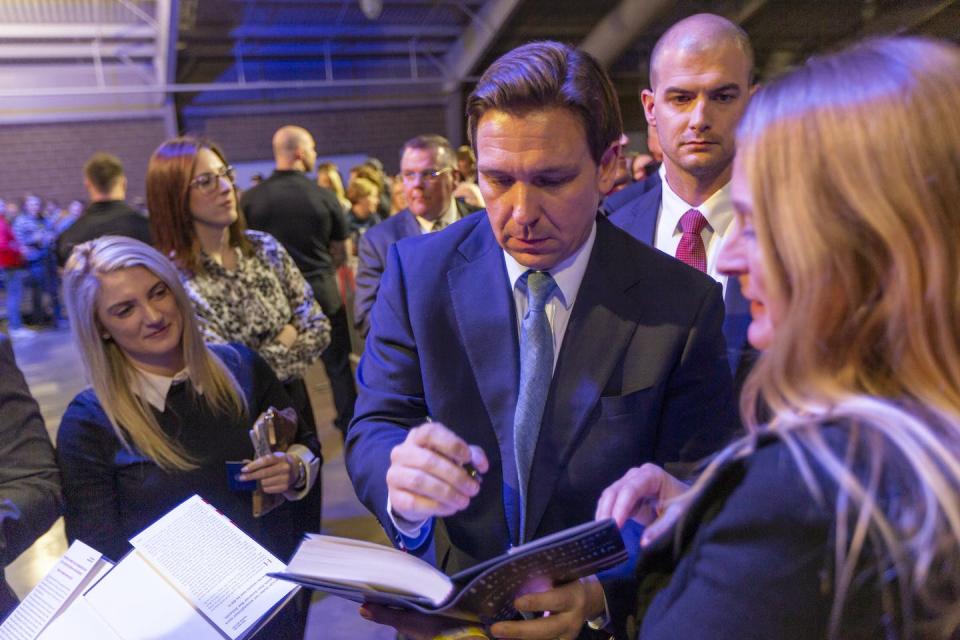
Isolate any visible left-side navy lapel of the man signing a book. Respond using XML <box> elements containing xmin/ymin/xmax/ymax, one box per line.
<box><xmin>447</xmin><ymin>220</ymin><xmax>520</xmax><ymax>468</ymax></box>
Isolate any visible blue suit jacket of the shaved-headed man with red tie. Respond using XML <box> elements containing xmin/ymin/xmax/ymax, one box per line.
<box><xmin>610</xmin><ymin>181</ymin><xmax>755</xmax><ymax>380</ymax></box>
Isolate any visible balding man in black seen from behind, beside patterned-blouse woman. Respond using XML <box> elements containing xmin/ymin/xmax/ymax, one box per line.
<box><xmin>240</xmin><ymin>125</ymin><xmax>357</xmax><ymax>435</ymax></box>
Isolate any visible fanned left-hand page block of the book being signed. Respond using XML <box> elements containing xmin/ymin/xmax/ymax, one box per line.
<box><xmin>287</xmin><ymin>534</ymin><xmax>453</xmax><ymax>605</ymax></box>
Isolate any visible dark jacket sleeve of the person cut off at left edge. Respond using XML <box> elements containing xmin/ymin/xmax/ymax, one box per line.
<box><xmin>0</xmin><ymin>335</ymin><xmax>63</xmax><ymax>621</ymax></box>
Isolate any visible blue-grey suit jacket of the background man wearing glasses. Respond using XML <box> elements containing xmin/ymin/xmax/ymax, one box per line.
<box><xmin>353</xmin><ymin>200</ymin><xmax>477</xmax><ymax>336</ymax></box>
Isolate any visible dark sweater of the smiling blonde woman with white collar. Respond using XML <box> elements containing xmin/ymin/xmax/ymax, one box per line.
<box><xmin>57</xmin><ymin>345</ymin><xmax>320</xmax><ymax>561</ymax></box>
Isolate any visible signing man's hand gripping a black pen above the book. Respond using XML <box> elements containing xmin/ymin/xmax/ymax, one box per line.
<box><xmin>387</xmin><ymin>422</ymin><xmax>490</xmax><ymax>523</ymax></box>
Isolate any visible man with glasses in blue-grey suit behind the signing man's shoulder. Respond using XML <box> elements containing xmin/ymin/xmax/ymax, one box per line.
<box><xmin>353</xmin><ymin>135</ymin><xmax>477</xmax><ymax>336</ymax></box>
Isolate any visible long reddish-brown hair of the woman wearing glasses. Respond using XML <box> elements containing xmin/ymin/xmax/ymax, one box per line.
<box><xmin>147</xmin><ymin>136</ymin><xmax>253</xmax><ymax>273</ymax></box>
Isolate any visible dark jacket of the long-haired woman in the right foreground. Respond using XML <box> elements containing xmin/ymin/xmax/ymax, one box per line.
<box><xmin>630</xmin><ymin>426</ymin><xmax>888</xmax><ymax>640</ymax></box>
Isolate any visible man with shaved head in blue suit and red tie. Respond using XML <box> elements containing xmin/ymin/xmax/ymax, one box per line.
<box><xmin>610</xmin><ymin>14</ymin><xmax>753</xmax><ymax>379</ymax></box>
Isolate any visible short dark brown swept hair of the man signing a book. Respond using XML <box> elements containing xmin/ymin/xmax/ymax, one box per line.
<box><xmin>467</xmin><ymin>41</ymin><xmax>623</xmax><ymax>165</ymax></box>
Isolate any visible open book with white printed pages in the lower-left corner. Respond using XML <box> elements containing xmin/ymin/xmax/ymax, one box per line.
<box><xmin>0</xmin><ymin>496</ymin><xmax>297</xmax><ymax>640</ymax></box>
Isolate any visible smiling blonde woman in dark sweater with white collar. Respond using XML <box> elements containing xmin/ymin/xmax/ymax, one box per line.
<box><xmin>57</xmin><ymin>236</ymin><xmax>320</xmax><ymax>560</ymax></box>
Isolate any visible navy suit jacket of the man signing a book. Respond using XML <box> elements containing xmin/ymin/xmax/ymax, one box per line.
<box><xmin>346</xmin><ymin>214</ymin><xmax>737</xmax><ymax>632</ymax></box>
